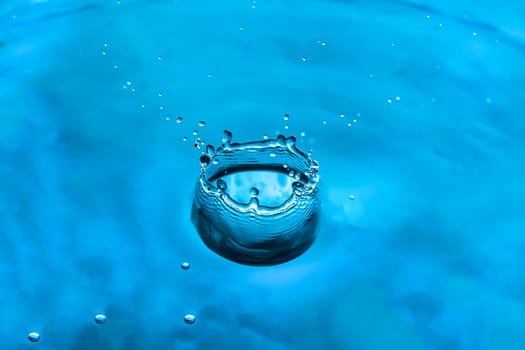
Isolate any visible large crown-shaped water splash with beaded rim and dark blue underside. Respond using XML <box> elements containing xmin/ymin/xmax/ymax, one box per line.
<box><xmin>191</xmin><ymin>131</ymin><xmax>320</xmax><ymax>266</ymax></box>
